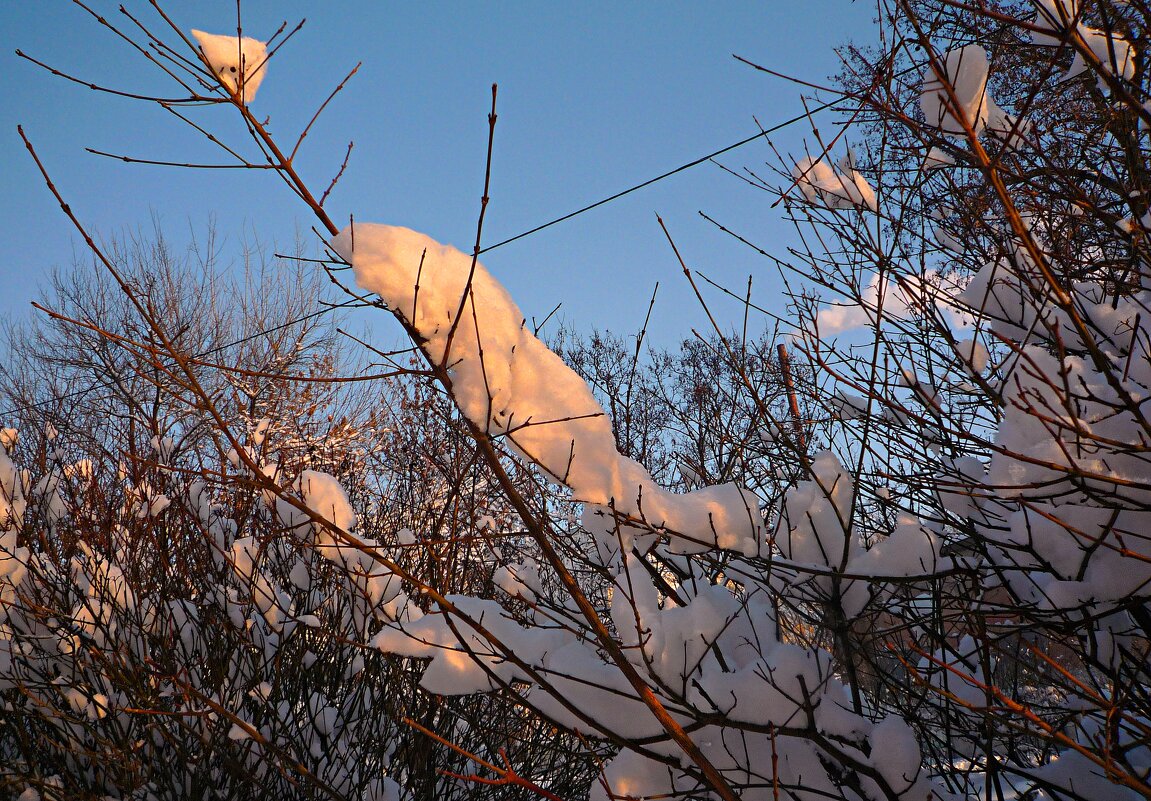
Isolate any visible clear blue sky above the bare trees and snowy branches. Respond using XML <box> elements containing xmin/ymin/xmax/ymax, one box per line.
<box><xmin>0</xmin><ymin>0</ymin><xmax>874</xmax><ymax>344</ymax></box>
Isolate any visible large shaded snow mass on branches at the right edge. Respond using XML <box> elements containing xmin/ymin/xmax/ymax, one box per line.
<box><xmin>911</xmin><ymin>226</ymin><xmax>1151</xmax><ymax>616</ymax></box>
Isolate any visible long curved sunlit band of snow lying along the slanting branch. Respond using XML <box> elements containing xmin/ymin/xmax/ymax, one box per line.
<box><xmin>331</xmin><ymin>223</ymin><xmax>762</xmax><ymax>554</ymax></box>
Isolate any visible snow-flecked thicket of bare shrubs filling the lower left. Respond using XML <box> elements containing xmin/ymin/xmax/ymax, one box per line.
<box><xmin>0</xmin><ymin>243</ymin><xmax>590</xmax><ymax>800</ymax></box>
